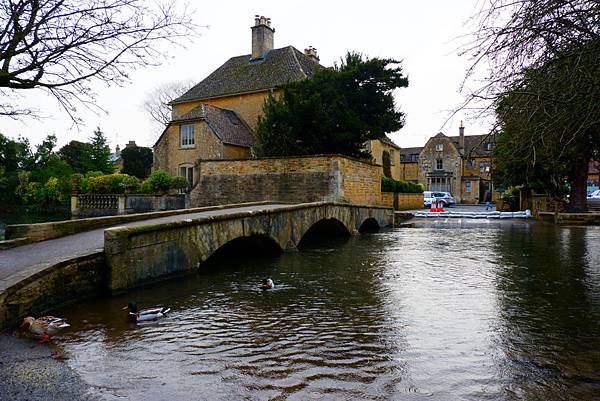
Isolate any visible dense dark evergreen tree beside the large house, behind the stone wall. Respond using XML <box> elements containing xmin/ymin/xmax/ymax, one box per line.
<box><xmin>256</xmin><ymin>53</ymin><xmax>408</xmax><ymax>158</ymax></box>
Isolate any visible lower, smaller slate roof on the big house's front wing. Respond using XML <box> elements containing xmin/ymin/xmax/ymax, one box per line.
<box><xmin>162</xmin><ymin>104</ymin><xmax>254</xmax><ymax>148</ymax></box>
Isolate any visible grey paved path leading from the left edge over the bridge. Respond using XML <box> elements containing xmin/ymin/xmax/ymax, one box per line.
<box><xmin>0</xmin><ymin>204</ymin><xmax>290</xmax><ymax>281</ymax></box>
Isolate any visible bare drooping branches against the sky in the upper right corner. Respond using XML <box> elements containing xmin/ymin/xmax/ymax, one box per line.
<box><xmin>461</xmin><ymin>0</ymin><xmax>600</xmax><ymax>110</ymax></box>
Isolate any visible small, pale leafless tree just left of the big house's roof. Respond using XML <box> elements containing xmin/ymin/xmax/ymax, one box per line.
<box><xmin>143</xmin><ymin>81</ymin><xmax>194</xmax><ymax>140</ymax></box>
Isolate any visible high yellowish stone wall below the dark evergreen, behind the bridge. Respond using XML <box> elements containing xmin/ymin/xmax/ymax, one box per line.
<box><xmin>190</xmin><ymin>155</ymin><xmax>383</xmax><ymax>206</ymax></box>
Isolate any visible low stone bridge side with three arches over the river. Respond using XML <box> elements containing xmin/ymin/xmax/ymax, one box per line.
<box><xmin>104</xmin><ymin>202</ymin><xmax>394</xmax><ymax>292</ymax></box>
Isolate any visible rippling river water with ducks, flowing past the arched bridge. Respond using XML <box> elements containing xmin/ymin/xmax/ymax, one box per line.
<box><xmin>55</xmin><ymin>222</ymin><xmax>600</xmax><ymax>400</ymax></box>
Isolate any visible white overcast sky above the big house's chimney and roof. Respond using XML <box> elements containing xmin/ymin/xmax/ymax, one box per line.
<box><xmin>0</xmin><ymin>0</ymin><xmax>488</xmax><ymax>149</ymax></box>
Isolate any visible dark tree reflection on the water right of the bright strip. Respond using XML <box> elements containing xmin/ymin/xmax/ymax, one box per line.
<box><xmin>496</xmin><ymin>225</ymin><xmax>600</xmax><ymax>399</ymax></box>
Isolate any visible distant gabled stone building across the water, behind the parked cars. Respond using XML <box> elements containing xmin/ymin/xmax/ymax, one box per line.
<box><xmin>400</xmin><ymin>123</ymin><xmax>496</xmax><ymax>203</ymax></box>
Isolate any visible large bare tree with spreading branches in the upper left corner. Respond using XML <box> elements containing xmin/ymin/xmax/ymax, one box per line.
<box><xmin>0</xmin><ymin>0</ymin><xmax>197</xmax><ymax>121</ymax></box>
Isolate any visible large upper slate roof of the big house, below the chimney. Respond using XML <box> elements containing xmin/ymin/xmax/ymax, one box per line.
<box><xmin>171</xmin><ymin>46</ymin><xmax>325</xmax><ymax>104</ymax></box>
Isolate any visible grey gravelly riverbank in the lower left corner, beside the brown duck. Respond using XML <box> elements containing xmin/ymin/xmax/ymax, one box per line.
<box><xmin>0</xmin><ymin>334</ymin><xmax>97</xmax><ymax>401</ymax></box>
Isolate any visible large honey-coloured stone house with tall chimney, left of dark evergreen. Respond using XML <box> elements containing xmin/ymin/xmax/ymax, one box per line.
<box><xmin>153</xmin><ymin>16</ymin><xmax>323</xmax><ymax>184</ymax></box>
